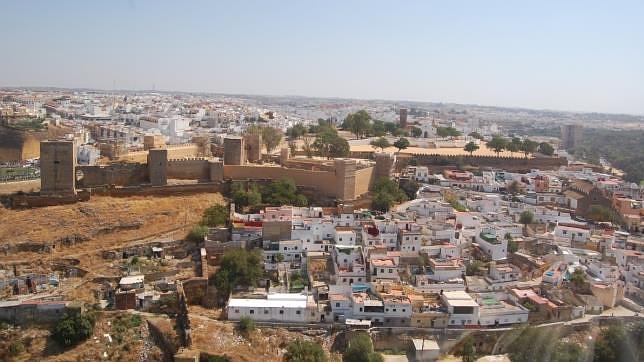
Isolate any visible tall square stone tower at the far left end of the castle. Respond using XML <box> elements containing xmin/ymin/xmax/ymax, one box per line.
<box><xmin>40</xmin><ymin>141</ymin><xmax>76</xmax><ymax>196</ymax></box>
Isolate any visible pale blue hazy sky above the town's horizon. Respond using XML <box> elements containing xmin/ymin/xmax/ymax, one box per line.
<box><xmin>0</xmin><ymin>0</ymin><xmax>644</xmax><ymax>114</ymax></box>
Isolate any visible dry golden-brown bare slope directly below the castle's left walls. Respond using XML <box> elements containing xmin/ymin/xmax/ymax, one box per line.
<box><xmin>0</xmin><ymin>194</ymin><xmax>224</xmax><ymax>263</ymax></box>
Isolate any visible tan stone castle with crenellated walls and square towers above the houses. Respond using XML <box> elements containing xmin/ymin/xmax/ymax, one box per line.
<box><xmin>31</xmin><ymin>135</ymin><xmax>395</xmax><ymax>206</ymax></box>
